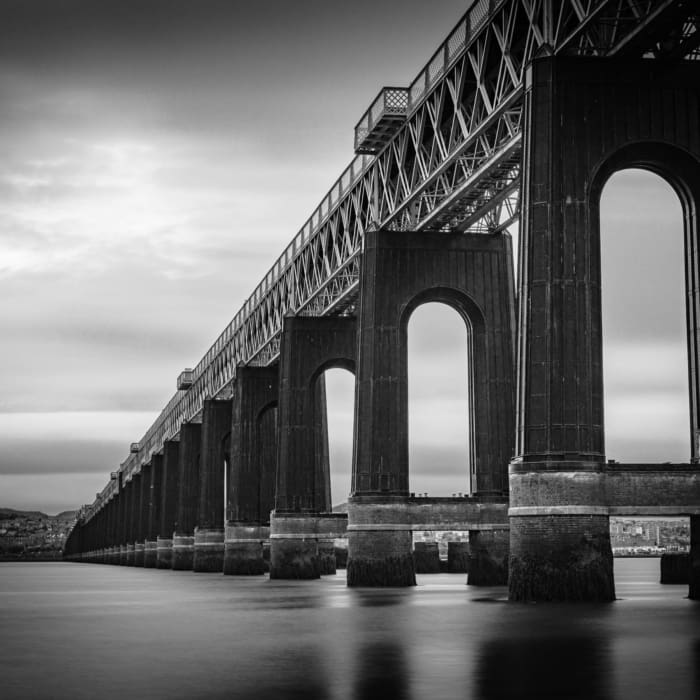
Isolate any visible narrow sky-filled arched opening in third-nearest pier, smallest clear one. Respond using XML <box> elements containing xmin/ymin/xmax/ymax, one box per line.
<box><xmin>321</xmin><ymin>367</ymin><xmax>355</xmax><ymax>511</ymax></box>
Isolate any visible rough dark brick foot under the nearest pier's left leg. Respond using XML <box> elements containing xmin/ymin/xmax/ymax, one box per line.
<box><xmin>508</xmin><ymin>515</ymin><xmax>615</xmax><ymax>602</ymax></box>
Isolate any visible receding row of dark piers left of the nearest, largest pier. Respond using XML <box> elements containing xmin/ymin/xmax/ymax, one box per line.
<box><xmin>66</xmin><ymin>231</ymin><xmax>514</xmax><ymax>585</ymax></box>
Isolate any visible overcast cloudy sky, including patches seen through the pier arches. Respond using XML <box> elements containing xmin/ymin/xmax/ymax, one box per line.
<box><xmin>0</xmin><ymin>0</ymin><xmax>688</xmax><ymax>513</ymax></box>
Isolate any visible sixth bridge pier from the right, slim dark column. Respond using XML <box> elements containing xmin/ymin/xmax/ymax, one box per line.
<box><xmin>172</xmin><ymin>423</ymin><xmax>202</xmax><ymax>571</ymax></box>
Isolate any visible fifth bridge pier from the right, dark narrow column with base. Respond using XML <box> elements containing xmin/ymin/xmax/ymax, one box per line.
<box><xmin>192</xmin><ymin>399</ymin><xmax>231</xmax><ymax>573</ymax></box>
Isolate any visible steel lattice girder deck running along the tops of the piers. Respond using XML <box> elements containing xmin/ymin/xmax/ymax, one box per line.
<box><xmin>89</xmin><ymin>0</ymin><xmax>700</xmax><ymax>512</ymax></box>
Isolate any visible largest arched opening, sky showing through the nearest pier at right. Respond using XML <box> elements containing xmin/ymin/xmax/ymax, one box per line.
<box><xmin>600</xmin><ymin>169</ymin><xmax>691</xmax><ymax>462</ymax></box>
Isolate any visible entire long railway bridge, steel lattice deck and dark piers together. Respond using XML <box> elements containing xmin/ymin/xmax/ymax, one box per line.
<box><xmin>66</xmin><ymin>0</ymin><xmax>700</xmax><ymax>600</ymax></box>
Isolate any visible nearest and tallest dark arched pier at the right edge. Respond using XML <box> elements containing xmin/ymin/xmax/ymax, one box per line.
<box><xmin>509</xmin><ymin>57</ymin><xmax>700</xmax><ymax>601</ymax></box>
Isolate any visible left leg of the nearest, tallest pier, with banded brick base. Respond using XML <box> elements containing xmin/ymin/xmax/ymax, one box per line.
<box><xmin>509</xmin><ymin>58</ymin><xmax>616</xmax><ymax>601</ymax></box>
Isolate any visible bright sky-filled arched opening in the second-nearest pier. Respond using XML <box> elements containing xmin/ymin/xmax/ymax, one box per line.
<box><xmin>408</xmin><ymin>302</ymin><xmax>471</xmax><ymax>496</ymax></box>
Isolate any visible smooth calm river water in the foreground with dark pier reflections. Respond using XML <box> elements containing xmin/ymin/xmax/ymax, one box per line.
<box><xmin>0</xmin><ymin>559</ymin><xmax>700</xmax><ymax>700</ymax></box>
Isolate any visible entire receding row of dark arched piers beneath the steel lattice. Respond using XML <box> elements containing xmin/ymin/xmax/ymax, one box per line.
<box><xmin>66</xmin><ymin>56</ymin><xmax>700</xmax><ymax>601</ymax></box>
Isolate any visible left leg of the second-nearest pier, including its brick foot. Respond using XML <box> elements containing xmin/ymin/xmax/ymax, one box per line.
<box><xmin>347</xmin><ymin>231</ymin><xmax>416</xmax><ymax>586</ymax></box>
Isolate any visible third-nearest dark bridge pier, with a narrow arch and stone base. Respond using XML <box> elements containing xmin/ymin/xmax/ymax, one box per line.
<box><xmin>270</xmin><ymin>316</ymin><xmax>357</xmax><ymax>579</ymax></box>
